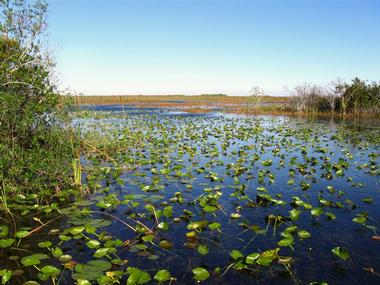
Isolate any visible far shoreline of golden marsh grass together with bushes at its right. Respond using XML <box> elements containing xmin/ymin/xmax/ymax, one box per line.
<box><xmin>73</xmin><ymin>78</ymin><xmax>380</xmax><ymax>118</ymax></box>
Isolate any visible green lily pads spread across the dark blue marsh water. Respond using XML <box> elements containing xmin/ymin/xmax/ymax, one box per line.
<box><xmin>0</xmin><ymin>113</ymin><xmax>380</xmax><ymax>285</ymax></box>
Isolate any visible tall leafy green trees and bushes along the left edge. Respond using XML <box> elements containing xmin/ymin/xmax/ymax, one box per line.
<box><xmin>0</xmin><ymin>1</ymin><xmax>72</xmax><ymax>206</ymax></box>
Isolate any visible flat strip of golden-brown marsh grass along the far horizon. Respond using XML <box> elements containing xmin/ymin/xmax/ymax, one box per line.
<box><xmin>67</xmin><ymin>94</ymin><xmax>379</xmax><ymax>119</ymax></box>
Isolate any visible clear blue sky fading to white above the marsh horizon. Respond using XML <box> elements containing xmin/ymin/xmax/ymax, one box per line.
<box><xmin>48</xmin><ymin>0</ymin><xmax>380</xmax><ymax>95</ymax></box>
